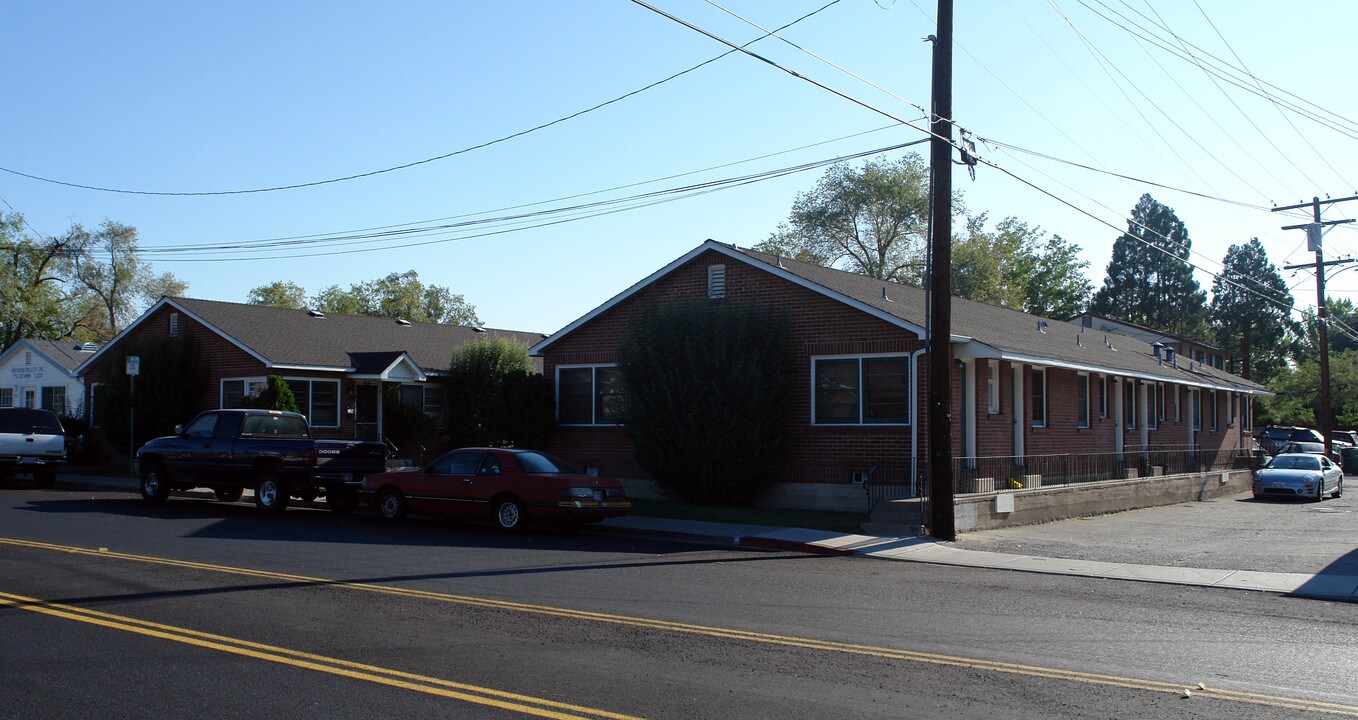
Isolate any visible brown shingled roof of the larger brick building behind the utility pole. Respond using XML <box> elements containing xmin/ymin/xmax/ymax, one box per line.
<box><xmin>532</xmin><ymin>240</ymin><xmax>1268</xmax><ymax>394</ymax></box>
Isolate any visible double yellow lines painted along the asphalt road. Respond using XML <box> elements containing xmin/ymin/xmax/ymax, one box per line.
<box><xmin>0</xmin><ymin>538</ymin><xmax>1358</xmax><ymax>719</ymax></box>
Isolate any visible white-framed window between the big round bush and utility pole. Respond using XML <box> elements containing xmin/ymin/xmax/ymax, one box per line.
<box><xmin>811</xmin><ymin>355</ymin><xmax>910</xmax><ymax>425</ymax></box>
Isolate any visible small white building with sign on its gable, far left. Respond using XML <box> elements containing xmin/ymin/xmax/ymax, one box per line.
<box><xmin>0</xmin><ymin>340</ymin><xmax>99</xmax><ymax>417</ymax></box>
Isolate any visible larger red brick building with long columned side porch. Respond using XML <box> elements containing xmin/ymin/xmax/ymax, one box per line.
<box><xmin>532</xmin><ymin>240</ymin><xmax>1266</xmax><ymax>509</ymax></box>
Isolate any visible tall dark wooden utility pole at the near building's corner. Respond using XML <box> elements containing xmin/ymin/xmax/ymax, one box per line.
<box><xmin>928</xmin><ymin>0</ymin><xmax>957</xmax><ymax>541</ymax></box>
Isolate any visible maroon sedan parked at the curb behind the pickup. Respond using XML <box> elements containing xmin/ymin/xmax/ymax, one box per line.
<box><xmin>359</xmin><ymin>447</ymin><xmax>631</xmax><ymax>530</ymax></box>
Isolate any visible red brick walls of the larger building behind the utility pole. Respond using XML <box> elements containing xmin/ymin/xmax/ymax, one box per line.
<box><xmin>543</xmin><ymin>251</ymin><xmax>1240</xmax><ymax>484</ymax></box>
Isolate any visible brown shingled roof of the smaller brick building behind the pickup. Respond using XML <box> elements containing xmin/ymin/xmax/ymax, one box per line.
<box><xmin>77</xmin><ymin>298</ymin><xmax>545</xmax><ymax>374</ymax></box>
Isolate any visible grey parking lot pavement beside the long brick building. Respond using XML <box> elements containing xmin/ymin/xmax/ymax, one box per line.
<box><xmin>952</xmin><ymin>493</ymin><xmax>1358</xmax><ymax>576</ymax></box>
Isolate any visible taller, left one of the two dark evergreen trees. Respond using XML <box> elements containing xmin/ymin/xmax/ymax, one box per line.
<box><xmin>1089</xmin><ymin>194</ymin><xmax>1207</xmax><ymax>337</ymax></box>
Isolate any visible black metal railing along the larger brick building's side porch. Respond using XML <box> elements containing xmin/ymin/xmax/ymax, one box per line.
<box><xmin>865</xmin><ymin>446</ymin><xmax>1259</xmax><ymax>512</ymax></box>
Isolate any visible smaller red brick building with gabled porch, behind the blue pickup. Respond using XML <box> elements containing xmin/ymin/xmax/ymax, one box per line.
<box><xmin>77</xmin><ymin>298</ymin><xmax>543</xmax><ymax>440</ymax></box>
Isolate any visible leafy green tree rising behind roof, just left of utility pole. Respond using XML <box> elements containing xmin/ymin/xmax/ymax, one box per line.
<box><xmin>755</xmin><ymin>154</ymin><xmax>934</xmax><ymax>285</ymax></box>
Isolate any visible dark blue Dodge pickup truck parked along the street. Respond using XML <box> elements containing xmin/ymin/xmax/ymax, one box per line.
<box><xmin>137</xmin><ymin>410</ymin><xmax>386</xmax><ymax>512</ymax></box>
